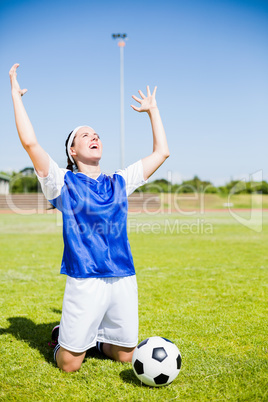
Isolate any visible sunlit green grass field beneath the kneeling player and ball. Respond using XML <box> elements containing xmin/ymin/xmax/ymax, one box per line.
<box><xmin>0</xmin><ymin>212</ymin><xmax>268</xmax><ymax>401</ymax></box>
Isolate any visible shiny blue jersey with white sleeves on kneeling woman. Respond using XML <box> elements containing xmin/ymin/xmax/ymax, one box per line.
<box><xmin>35</xmin><ymin>158</ymin><xmax>145</xmax><ymax>278</ymax></box>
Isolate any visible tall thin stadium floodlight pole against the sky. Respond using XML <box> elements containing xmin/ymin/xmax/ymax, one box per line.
<box><xmin>112</xmin><ymin>33</ymin><xmax>127</xmax><ymax>169</ymax></box>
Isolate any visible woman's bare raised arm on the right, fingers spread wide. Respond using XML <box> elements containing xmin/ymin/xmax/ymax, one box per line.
<box><xmin>131</xmin><ymin>86</ymin><xmax>169</xmax><ymax>180</ymax></box>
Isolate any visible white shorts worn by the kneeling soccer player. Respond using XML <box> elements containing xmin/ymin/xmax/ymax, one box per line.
<box><xmin>59</xmin><ymin>275</ymin><xmax>138</xmax><ymax>353</ymax></box>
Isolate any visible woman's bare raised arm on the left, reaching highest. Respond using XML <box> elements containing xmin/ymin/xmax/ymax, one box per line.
<box><xmin>9</xmin><ymin>64</ymin><xmax>49</xmax><ymax>177</ymax></box>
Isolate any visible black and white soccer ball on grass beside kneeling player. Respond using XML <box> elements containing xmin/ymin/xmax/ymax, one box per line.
<box><xmin>132</xmin><ymin>336</ymin><xmax>181</xmax><ymax>387</ymax></box>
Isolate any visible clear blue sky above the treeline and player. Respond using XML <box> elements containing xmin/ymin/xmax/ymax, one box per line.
<box><xmin>0</xmin><ymin>0</ymin><xmax>268</xmax><ymax>185</ymax></box>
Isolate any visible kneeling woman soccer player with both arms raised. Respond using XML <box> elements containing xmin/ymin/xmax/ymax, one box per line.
<box><xmin>9</xmin><ymin>64</ymin><xmax>169</xmax><ymax>372</ymax></box>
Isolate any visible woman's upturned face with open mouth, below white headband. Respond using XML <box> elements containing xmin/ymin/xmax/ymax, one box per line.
<box><xmin>70</xmin><ymin>126</ymin><xmax>102</xmax><ymax>163</ymax></box>
